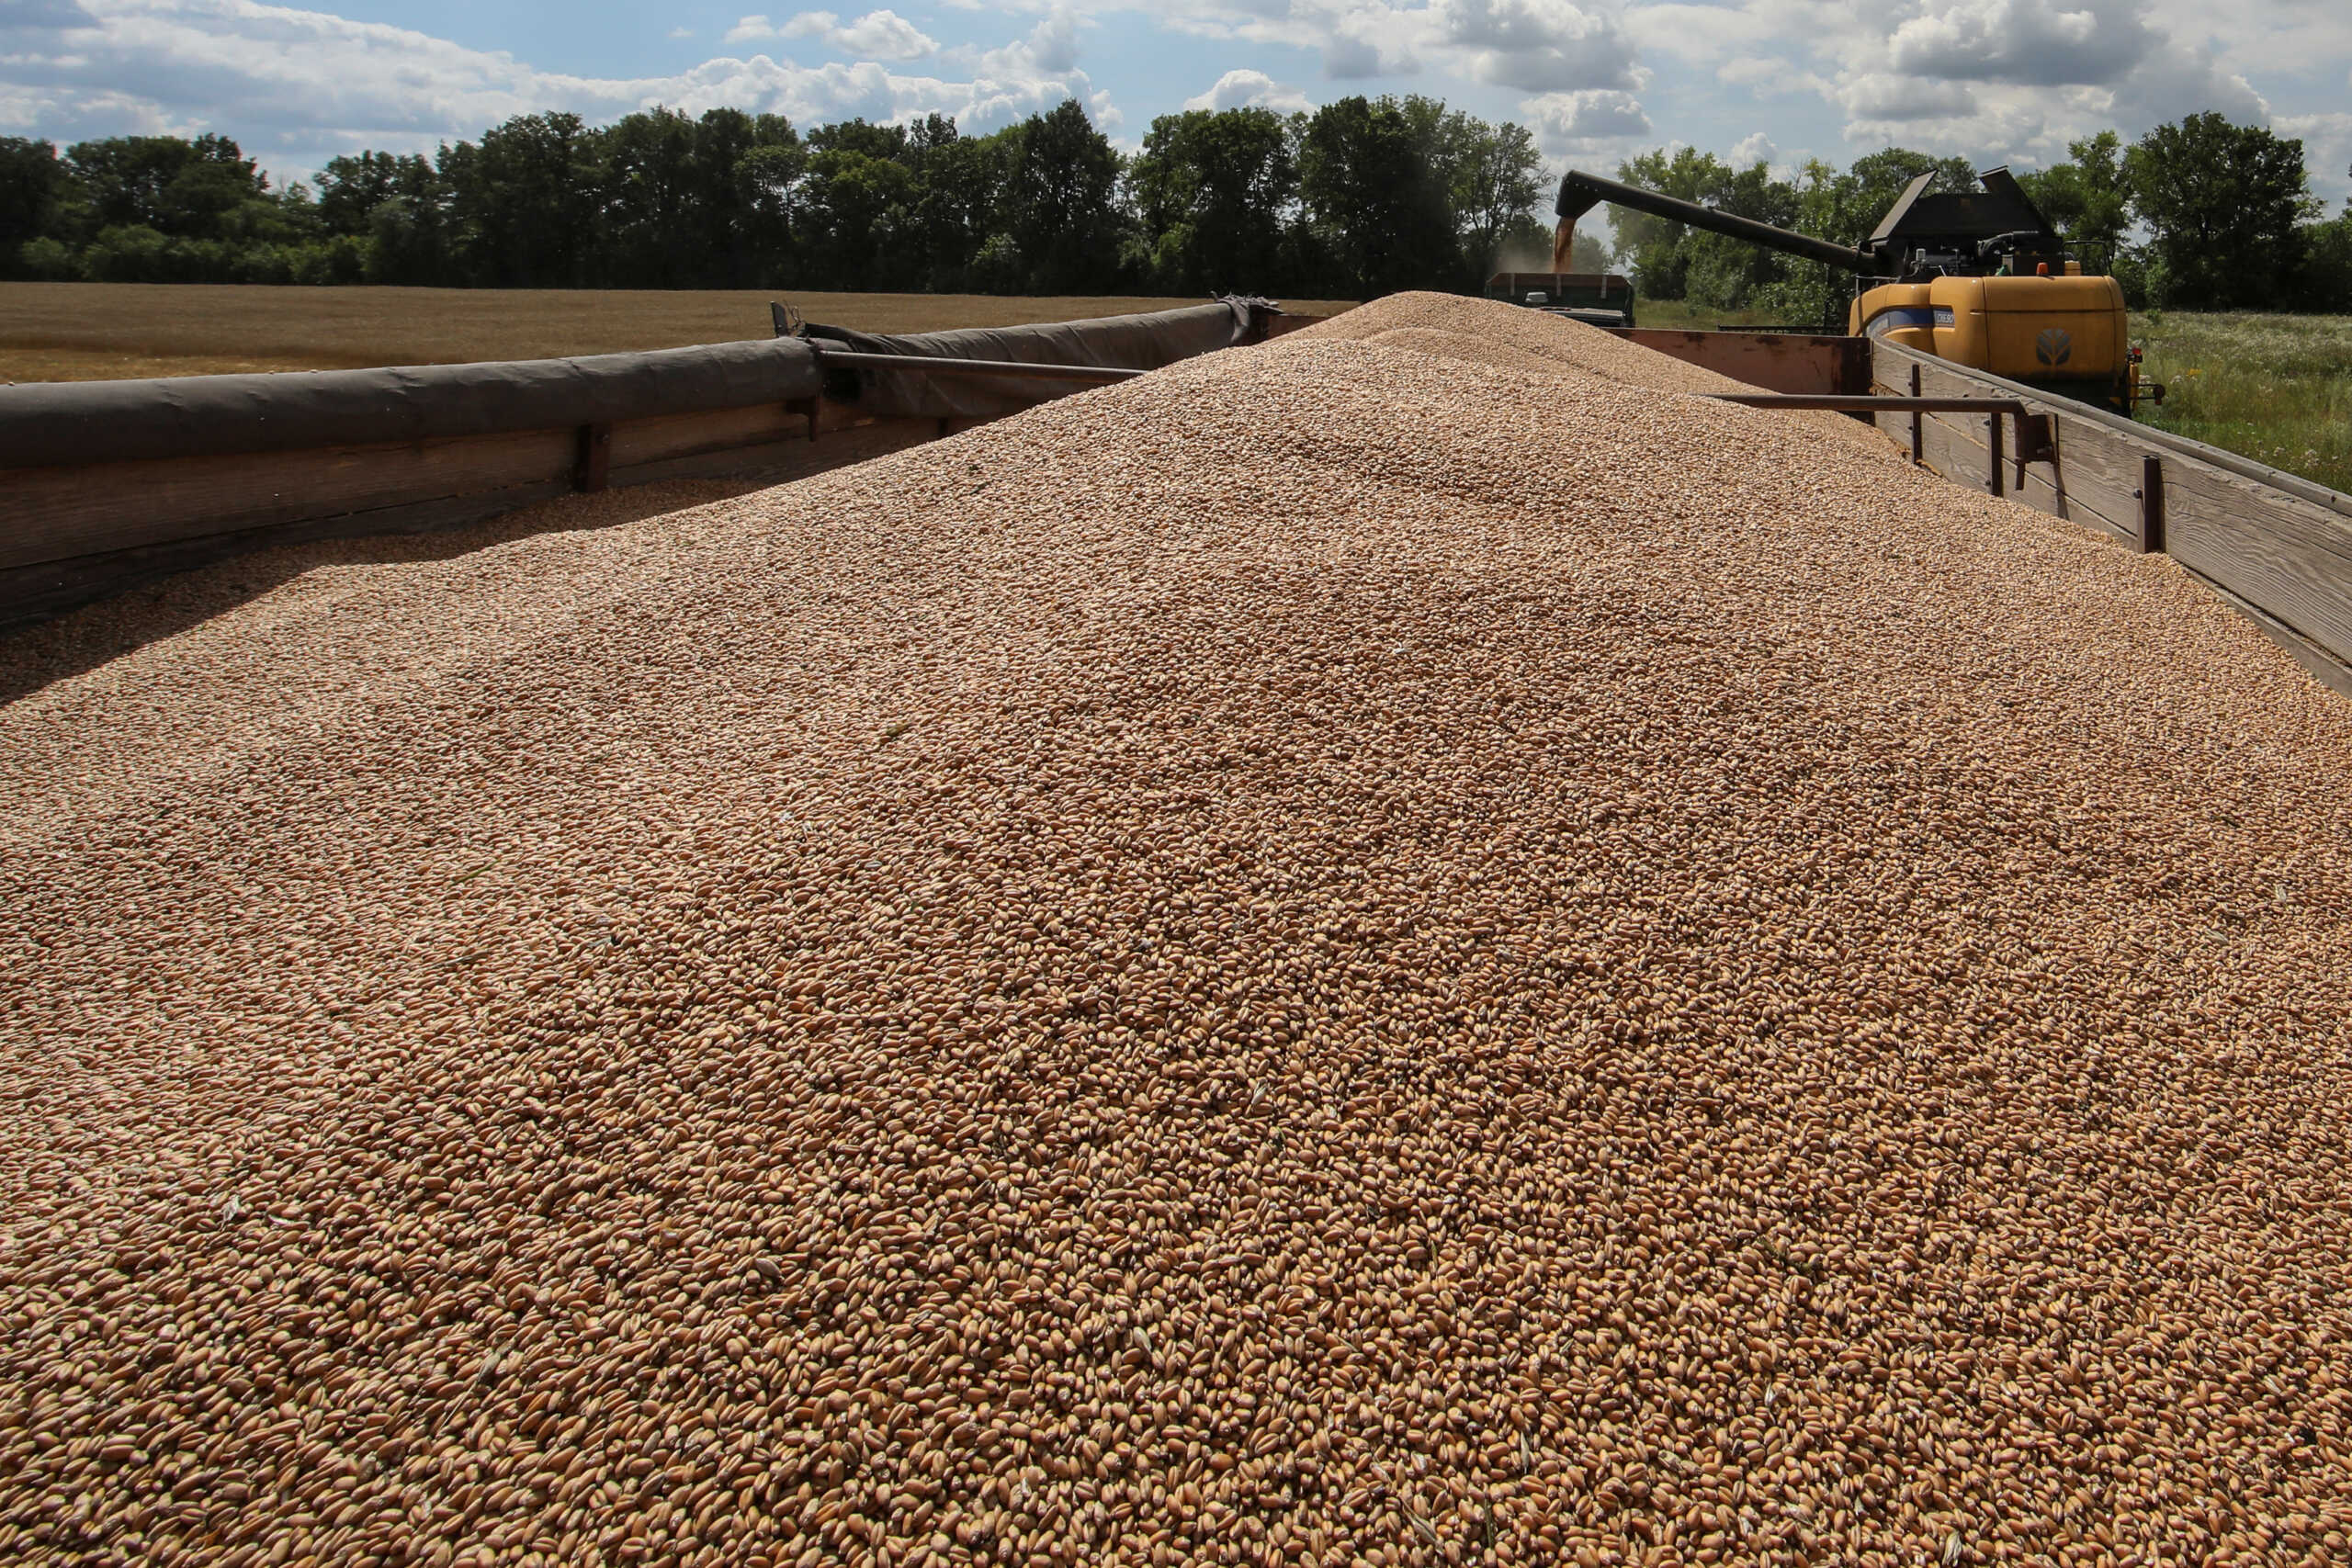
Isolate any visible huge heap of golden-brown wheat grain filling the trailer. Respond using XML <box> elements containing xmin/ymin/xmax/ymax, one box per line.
<box><xmin>0</xmin><ymin>297</ymin><xmax>2352</xmax><ymax>1565</ymax></box>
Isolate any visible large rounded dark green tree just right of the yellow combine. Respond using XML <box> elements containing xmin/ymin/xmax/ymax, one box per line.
<box><xmin>2124</xmin><ymin>113</ymin><xmax>2319</xmax><ymax>310</ymax></box>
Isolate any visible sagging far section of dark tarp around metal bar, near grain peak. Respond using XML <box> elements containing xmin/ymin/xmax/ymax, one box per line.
<box><xmin>807</xmin><ymin>299</ymin><xmax>1272</xmax><ymax>419</ymax></box>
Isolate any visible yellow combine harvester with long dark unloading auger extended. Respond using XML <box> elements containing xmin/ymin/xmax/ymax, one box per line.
<box><xmin>1557</xmin><ymin>169</ymin><xmax>2164</xmax><ymax>413</ymax></box>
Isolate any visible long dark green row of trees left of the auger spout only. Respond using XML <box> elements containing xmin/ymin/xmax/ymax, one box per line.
<box><xmin>0</xmin><ymin>96</ymin><xmax>1550</xmax><ymax>299</ymax></box>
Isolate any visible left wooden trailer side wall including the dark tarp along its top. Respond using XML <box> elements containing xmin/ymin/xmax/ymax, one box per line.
<box><xmin>0</xmin><ymin>303</ymin><xmax>1317</xmax><ymax>626</ymax></box>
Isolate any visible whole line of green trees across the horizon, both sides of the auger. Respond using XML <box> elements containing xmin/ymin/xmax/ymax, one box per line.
<box><xmin>0</xmin><ymin>96</ymin><xmax>2352</xmax><ymax>310</ymax></box>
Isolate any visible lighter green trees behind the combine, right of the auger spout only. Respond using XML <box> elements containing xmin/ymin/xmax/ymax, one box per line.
<box><xmin>1616</xmin><ymin>113</ymin><xmax>2352</xmax><ymax>324</ymax></box>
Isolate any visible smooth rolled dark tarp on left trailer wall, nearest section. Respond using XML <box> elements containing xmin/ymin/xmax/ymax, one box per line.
<box><xmin>0</xmin><ymin>339</ymin><xmax>823</xmax><ymax>468</ymax></box>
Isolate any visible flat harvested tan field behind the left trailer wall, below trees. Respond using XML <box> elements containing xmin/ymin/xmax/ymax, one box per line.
<box><xmin>0</xmin><ymin>282</ymin><xmax>1348</xmax><ymax>381</ymax></box>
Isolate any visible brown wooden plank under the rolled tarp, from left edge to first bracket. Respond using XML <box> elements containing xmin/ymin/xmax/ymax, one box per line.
<box><xmin>0</xmin><ymin>428</ymin><xmax>579</xmax><ymax>567</ymax></box>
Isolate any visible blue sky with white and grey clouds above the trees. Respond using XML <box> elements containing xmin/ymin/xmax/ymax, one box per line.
<box><xmin>0</xmin><ymin>0</ymin><xmax>2352</xmax><ymax>209</ymax></box>
